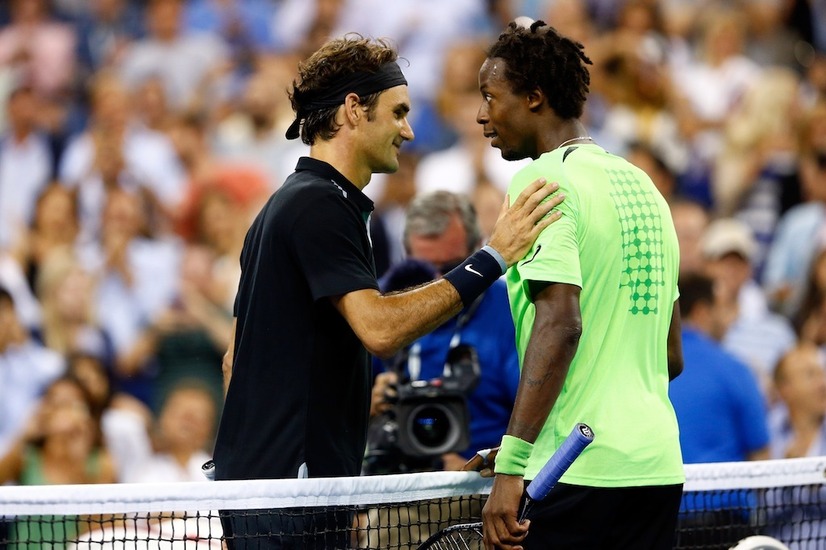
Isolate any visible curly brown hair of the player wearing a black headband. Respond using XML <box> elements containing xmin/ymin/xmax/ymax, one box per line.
<box><xmin>289</xmin><ymin>33</ymin><xmax>399</xmax><ymax>145</ymax></box>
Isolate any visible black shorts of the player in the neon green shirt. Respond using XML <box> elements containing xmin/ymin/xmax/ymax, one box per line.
<box><xmin>523</xmin><ymin>483</ymin><xmax>683</xmax><ymax>550</ymax></box>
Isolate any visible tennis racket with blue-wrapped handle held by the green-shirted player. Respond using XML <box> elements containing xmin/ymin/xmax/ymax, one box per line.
<box><xmin>418</xmin><ymin>423</ymin><xmax>594</xmax><ymax>550</ymax></box>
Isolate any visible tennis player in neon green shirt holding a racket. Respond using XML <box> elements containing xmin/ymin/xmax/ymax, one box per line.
<box><xmin>477</xmin><ymin>21</ymin><xmax>685</xmax><ymax>550</ymax></box>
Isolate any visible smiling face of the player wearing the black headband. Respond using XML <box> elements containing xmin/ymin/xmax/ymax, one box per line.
<box><xmin>364</xmin><ymin>86</ymin><xmax>414</xmax><ymax>173</ymax></box>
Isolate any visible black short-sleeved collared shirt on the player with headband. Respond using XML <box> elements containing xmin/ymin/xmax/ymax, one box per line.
<box><xmin>214</xmin><ymin>157</ymin><xmax>378</xmax><ymax>479</ymax></box>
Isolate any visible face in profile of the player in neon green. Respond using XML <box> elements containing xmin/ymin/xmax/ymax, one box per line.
<box><xmin>476</xmin><ymin>58</ymin><xmax>530</xmax><ymax>160</ymax></box>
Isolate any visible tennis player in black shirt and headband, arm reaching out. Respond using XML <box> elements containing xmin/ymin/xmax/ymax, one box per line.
<box><xmin>209</xmin><ymin>35</ymin><xmax>562</xmax><ymax>548</ymax></box>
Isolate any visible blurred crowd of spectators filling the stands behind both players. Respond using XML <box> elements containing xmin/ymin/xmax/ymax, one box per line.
<box><xmin>0</xmin><ymin>0</ymin><xmax>826</xmax><ymax>496</ymax></box>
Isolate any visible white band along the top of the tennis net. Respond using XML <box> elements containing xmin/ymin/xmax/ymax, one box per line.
<box><xmin>0</xmin><ymin>457</ymin><xmax>826</xmax><ymax>516</ymax></box>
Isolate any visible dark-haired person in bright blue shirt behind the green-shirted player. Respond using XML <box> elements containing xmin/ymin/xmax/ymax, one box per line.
<box><xmin>668</xmin><ymin>273</ymin><xmax>769</xmax><ymax>549</ymax></box>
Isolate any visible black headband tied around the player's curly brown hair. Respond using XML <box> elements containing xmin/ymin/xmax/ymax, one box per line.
<box><xmin>286</xmin><ymin>61</ymin><xmax>407</xmax><ymax>139</ymax></box>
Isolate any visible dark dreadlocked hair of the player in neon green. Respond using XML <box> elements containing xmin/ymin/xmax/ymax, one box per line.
<box><xmin>487</xmin><ymin>21</ymin><xmax>593</xmax><ymax>119</ymax></box>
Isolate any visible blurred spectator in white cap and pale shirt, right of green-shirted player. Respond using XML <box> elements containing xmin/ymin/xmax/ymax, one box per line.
<box><xmin>702</xmin><ymin>218</ymin><xmax>797</xmax><ymax>396</ymax></box>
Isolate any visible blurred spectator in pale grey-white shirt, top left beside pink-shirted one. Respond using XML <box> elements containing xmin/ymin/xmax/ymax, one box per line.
<box><xmin>119</xmin><ymin>0</ymin><xmax>230</xmax><ymax>111</ymax></box>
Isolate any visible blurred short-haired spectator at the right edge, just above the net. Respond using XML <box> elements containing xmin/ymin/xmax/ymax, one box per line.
<box><xmin>769</xmin><ymin>343</ymin><xmax>826</xmax><ymax>458</ymax></box>
